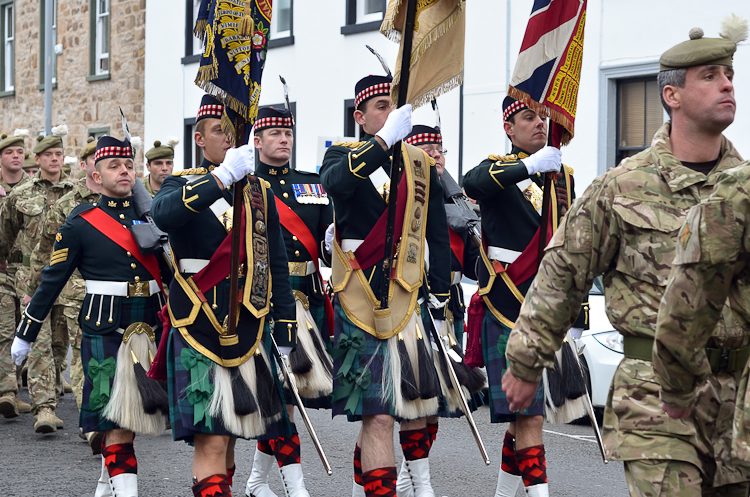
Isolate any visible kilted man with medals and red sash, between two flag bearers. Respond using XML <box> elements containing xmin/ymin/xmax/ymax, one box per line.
<box><xmin>245</xmin><ymin>107</ymin><xmax>333</xmax><ymax>497</ymax></box>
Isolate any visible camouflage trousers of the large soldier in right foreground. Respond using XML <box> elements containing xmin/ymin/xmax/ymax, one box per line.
<box><xmin>625</xmin><ymin>460</ymin><xmax>750</xmax><ymax>497</ymax></box>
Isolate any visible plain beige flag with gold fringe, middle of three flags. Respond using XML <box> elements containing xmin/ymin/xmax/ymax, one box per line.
<box><xmin>380</xmin><ymin>0</ymin><xmax>466</xmax><ymax>108</ymax></box>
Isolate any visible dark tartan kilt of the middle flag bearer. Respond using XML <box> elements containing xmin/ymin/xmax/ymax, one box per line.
<box><xmin>331</xmin><ymin>298</ymin><xmax>396</xmax><ymax>422</ymax></box>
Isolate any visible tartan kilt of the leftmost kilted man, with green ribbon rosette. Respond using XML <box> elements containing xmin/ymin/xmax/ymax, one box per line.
<box><xmin>78</xmin><ymin>298</ymin><xmax>162</xmax><ymax>433</ymax></box>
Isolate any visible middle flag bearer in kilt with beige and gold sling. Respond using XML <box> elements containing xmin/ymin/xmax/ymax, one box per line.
<box><xmin>320</xmin><ymin>76</ymin><xmax>450</xmax><ymax>496</ymax></box>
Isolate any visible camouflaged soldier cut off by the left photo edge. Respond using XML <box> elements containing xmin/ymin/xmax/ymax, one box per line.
<box><xmin>0</xmin><ymin>130</ymin><xmax>31</xmax><ymax>418</ymax></box>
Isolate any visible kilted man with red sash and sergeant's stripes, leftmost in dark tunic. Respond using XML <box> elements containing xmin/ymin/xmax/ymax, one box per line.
<box><xmin>13</xmin><ymin>137</ymin><xmax>168</xmax><ymax>496</ymax></box>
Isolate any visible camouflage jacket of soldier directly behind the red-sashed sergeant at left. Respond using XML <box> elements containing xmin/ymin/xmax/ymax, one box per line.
<box><xmin>26</xmin><ymin>177</ymin><xmax>99</xmax><ymax>306</ymax></box>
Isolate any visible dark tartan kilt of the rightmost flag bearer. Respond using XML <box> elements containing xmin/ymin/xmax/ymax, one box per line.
<box><xmin>482</xmin><ymin>304</ymin><xmax>544</xmax><ymax>423</ymax></box>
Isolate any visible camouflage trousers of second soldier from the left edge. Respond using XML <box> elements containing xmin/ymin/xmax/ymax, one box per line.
<box><xmin>26</xmin><ymin>304</ymin><xmax>68</xmax><ymax>414</ymax></box>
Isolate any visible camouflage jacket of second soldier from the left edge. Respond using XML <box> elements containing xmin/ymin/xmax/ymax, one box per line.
<box><xmin>0</xmin><ymin>174</ymin><xmax>73</xmax><ymax>290</ymax></box>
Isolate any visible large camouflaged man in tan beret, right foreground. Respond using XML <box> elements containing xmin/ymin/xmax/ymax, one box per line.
<box><xmin>503</xmin><ymin>23</ymin><xmax>750</xmax><ymax>497</ymax></box>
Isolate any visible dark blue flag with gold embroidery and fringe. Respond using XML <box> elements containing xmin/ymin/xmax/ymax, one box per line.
<box><xmin>195</xmin><ymin>0</ymin><xmax>271</xmax><ymax>146</ymax></box>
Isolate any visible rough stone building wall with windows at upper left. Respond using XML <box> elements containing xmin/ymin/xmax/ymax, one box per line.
<box><xmin>0</xmin><ymin>0</ymin><xmax>146</xmax><ymax>175</ymax></box>
